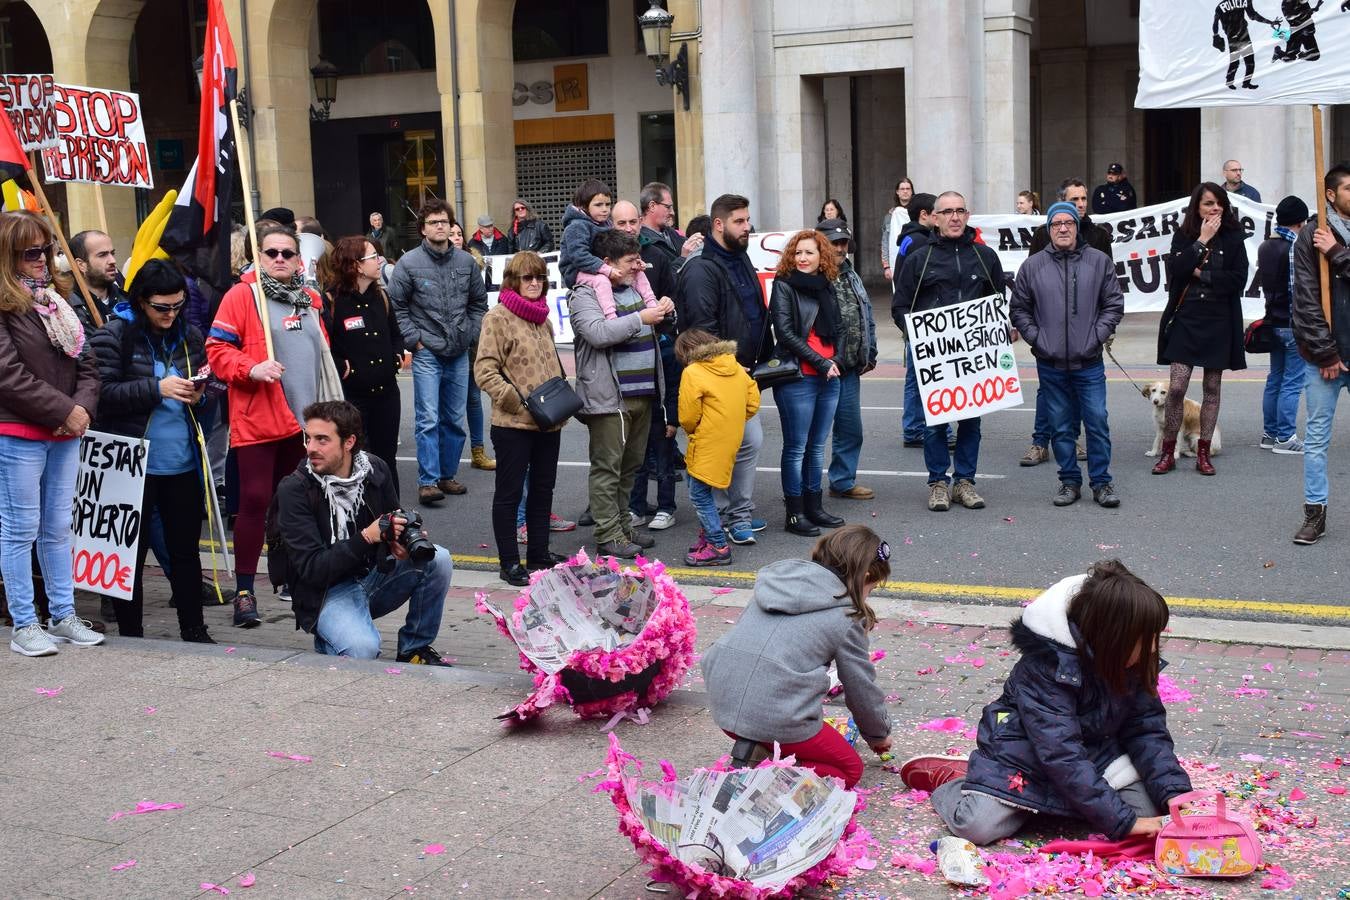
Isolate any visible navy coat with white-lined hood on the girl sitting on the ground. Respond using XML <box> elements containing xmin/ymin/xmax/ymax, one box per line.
<box><xmin>964</xmin><ymin>575</ymin><xmax>1191</xmax><ymax>841</ymax></box>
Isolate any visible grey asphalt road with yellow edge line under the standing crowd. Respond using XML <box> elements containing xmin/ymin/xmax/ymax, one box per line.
<box><xmin>380</xmin><ymin>314</ymin><xmax>1350</xmax><ymax>623</ymax></box>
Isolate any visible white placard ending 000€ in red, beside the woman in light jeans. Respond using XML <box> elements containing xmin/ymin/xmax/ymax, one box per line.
<box><xmin>70</xmin><ymin>430</ymin><xmax>150</xmax><ymax>600</ymax></box>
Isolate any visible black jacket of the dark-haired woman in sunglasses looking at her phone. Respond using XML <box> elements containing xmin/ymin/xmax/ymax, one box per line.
<box><xmin>89</xmin><ymin>302</ymin><xmax>207</xmax><ymax>437</ymax></box>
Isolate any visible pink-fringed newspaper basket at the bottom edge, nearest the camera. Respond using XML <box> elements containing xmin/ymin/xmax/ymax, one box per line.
<box><xmin>595</xmin><ymin>733</ymin><xmax>876</xmax><ymax>900</ymax></box>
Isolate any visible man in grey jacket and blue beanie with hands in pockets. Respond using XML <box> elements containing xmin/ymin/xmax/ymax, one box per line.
<box><xmin>1010</xmin><ymin>201</ymin><xmax>1125</xmax><ymax>509</ymax></box>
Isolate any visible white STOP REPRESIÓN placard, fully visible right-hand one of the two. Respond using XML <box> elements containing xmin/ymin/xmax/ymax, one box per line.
<box><xmin>42</xmin><ymin>85</ymin><xmax>155</xmax><ymax>188</ymax></box>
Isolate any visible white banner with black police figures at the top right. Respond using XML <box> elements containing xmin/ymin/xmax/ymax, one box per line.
<box><xmin>1134</xmin><ymin>0</ymin><xmax>1350</xmax><ymax>109</ymax></box>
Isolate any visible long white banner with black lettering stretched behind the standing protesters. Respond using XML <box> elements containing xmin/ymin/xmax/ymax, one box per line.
<box><xmin>971</xmin><ymin>194</ymin><xmax>1274</xmax><ymax>318</ymax></box>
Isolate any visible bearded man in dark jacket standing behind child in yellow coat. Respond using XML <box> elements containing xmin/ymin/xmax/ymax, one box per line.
<box><xmin>676</xmin><ymin>194</ymin><xmax>774</xmax><ymax>544</ymax></box>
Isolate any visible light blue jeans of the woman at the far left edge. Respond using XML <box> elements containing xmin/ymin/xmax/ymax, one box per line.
<box><xmin>0</xmin><ymin>434</ymin><xmax>78</xmax><ymax>627</ymax></box>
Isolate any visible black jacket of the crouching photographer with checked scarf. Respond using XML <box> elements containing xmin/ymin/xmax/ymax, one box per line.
<box><xmin>277</xmin><ymin>453</ymin><xmax>400</xmax><ymax>631</ymax></box>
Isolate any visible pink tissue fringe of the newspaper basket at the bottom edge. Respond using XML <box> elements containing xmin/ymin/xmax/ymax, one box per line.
<box><xmin>593</xmin><ymin>734</ymin><xmax>876</xmax><ymax>900</ymax></box>
